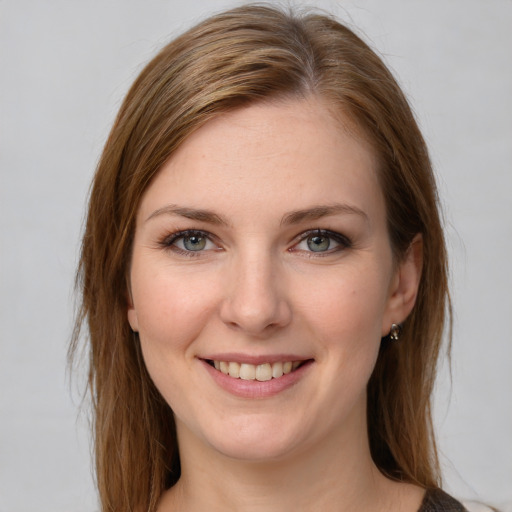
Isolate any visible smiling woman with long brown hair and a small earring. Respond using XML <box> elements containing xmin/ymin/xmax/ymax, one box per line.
<box><xmin>75</xmin><ymin>6</ymin><xmax>464</xmax><ymax>512</ymax></box>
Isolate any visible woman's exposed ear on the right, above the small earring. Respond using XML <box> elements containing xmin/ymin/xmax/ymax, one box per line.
<box><xmin>382</xmin><ymin>233</ymin><xmax>423</xmax><ymax>336</ymax></box>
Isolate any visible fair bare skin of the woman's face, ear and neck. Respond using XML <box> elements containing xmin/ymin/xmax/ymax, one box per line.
<box><xmin>127</xmin><ymin>98</ymin><xmax>422</xmax><ymax>511</ymax></box>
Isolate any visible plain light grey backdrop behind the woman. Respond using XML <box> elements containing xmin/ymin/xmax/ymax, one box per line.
<box><xmin>0</xmin><ymin>0</ymin><xmax>512</xmax><ymax>512</ymax></box>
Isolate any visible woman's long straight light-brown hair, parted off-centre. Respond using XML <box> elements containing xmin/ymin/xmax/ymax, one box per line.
<box><xmin>70</xmin><ymin>5</ymin><xmax>450</xmax><ymax>511</ymax></box>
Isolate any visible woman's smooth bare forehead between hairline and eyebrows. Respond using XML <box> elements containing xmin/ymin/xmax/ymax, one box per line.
<box><xmin>136</xmin><ymin>98</ymin><xmax>382</xmax><ymax>224</ymax></box>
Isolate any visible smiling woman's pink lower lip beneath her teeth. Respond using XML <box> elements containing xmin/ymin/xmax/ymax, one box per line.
<box><xmin>201</xmin><ymin>360</ymin><xmax>313</xmax><ymax>398</ymax></box>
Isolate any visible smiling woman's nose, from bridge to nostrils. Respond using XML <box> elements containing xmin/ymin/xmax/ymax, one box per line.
<box><xmin>220</xmin><ymin>251</ymin><xmax>292</xmax><ymax>337</ymax></box>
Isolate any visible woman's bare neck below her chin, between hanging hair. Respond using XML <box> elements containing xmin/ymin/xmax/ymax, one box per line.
<box><xmin>159</xmin><ymin>412</ymin><xmax>423</xmax><ymax>512</ymax></box>
